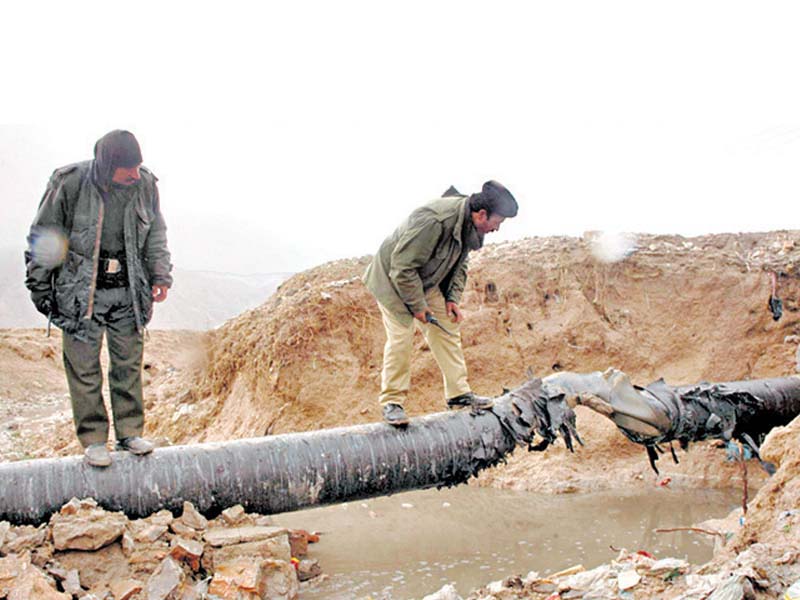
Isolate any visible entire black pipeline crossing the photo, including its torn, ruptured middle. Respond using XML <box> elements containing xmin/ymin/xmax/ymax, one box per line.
<box><xmin>6</xmin><ymin>371</ymin><xmax>800</xmax><ymax>524</ymax></box>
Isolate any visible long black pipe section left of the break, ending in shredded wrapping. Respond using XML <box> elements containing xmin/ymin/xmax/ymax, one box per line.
<box><xmin>0</xmin><ymin>379</ymin><xmax>577</xmax><ymax>524</ymax></box>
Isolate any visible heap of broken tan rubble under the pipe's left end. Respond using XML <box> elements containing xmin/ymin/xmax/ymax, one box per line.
<box><xmin>0</xmin><ymin>498</ymin><xmax>322</xmax><ymax>600</ymax></box>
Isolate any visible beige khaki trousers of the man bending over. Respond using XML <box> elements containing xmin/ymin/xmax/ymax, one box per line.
<box><xmin>378</xmin><ymin>288</ymin><xmax>470</xmax><ymax>406</ymax></box>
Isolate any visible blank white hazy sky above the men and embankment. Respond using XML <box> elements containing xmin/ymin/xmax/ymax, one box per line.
<box><xmin>0</xmin><ymin>0</ymin><xmax>800</xmax><ymax>273</ymax></box>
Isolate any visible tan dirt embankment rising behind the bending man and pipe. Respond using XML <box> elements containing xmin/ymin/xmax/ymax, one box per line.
<box><xmin>138</xmin><ymin>231</ymin><xmax>800</xmax><ymax>492</ymax></box>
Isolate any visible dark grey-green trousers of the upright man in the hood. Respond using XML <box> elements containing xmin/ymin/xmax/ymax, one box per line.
<box><xmin>62</xmin><ymin>288</ymin><xmax>144</xmax><ymax>447</ymax></box>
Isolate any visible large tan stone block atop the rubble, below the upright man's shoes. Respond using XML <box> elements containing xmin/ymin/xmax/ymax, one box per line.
<box><xmin>50</xmin><ymin>501</ymin><xmax>128</xmax><ymax>550</ymax></box>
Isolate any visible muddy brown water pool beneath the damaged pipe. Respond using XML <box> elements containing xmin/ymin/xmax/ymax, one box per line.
<box><xmin>275</xmin><ymin>486</ymin><xmax>740</xmax><ymax>600</ymax></box>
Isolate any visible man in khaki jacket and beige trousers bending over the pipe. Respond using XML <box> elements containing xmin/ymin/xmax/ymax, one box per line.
<box><xmin>364</xmin><ymin>181</ymin><xmax>517</xmax><ymax>426</ymax></box>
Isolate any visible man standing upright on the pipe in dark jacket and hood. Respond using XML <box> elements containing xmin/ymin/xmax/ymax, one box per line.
<box><xmin>25</xmin><ymin>130</ymin><xmax>172</xmax><ymax>467</ymax></box>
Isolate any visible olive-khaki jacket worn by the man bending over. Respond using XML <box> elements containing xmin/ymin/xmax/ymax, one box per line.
<box><xmin>364</xmin><ymin>196</ymin><xmax>483</xmax><ymax>324</ymax></box>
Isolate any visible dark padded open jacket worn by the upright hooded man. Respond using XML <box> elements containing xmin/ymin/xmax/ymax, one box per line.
<box><xmin>25</xmin><ymin>161</ymin><xmax>172</xmax><ymax>337</ymax></box>
